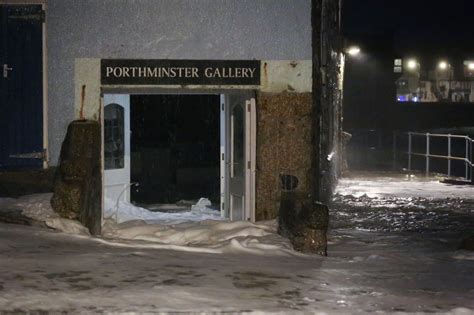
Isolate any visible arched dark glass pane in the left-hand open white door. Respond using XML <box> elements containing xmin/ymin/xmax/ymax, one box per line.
<box><xmin>104</xmin><ymin>104</ymin><xmax>125</xmax><ymax>170</ymax></box>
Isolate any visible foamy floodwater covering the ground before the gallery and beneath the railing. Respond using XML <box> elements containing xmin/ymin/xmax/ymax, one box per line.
<box><xmin>0</xmin><ymin>174</ymin><xmax>474</xmax><ymax>314</ymax></box>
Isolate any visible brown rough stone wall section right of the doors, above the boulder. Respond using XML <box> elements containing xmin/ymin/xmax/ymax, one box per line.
<box><xmin>256</xmin><ymin>93</ymin><xmax>313</xmax><ymax>221</ymax></box>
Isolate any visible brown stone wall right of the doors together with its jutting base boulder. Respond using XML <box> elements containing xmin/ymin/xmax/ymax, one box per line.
<box><xmin>256</xmin><ymin>92</ymin><xmax>328</xmax><ymax>255</ymax></box>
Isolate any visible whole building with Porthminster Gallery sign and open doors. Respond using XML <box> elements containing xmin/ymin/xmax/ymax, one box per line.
<box><xmin>0</xmin><ymin>0</ymin><xmax>344</xmax><ymax>244</ymax></box>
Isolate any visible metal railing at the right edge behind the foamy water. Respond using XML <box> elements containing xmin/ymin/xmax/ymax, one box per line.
<box><xmin>402</xmin><ymin>132</ymin><xmax>474</xmax><ymax>181</ymax></box>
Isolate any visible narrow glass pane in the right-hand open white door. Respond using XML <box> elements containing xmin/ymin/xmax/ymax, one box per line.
<box><xmin>231</xmin><ymin>105</ymin><xmax>244</xmax><ymax>177</ymax></box>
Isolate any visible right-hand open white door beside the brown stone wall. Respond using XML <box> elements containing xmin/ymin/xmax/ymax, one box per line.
<box><xmin>221</xmin><ymin>93</ymin><xmax>256</xmax><ymax>221</ymax></box>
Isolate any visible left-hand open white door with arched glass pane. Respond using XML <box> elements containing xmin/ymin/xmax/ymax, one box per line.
<box><xmin>104</xmin><ymin>94</ymin><xmax>130</xmax><ymax>204</ymax></box>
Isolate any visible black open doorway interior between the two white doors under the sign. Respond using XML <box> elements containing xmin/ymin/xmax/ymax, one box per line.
<box><xmin>130</xmin><ymin>95</ymin><xmax>220</xmax><ymax>208</ymax></box>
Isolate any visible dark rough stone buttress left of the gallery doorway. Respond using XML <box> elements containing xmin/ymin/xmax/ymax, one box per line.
<box><xmin>51</xmin><ymin>120</ymin><xmax>102</xmax><ymax>235</ymax></box>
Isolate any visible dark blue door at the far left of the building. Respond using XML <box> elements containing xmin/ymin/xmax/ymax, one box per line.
<box><xmin>0</xmin><ymin>5</ymin><xmax>44</xmax><ymax>169</ymax></box>
